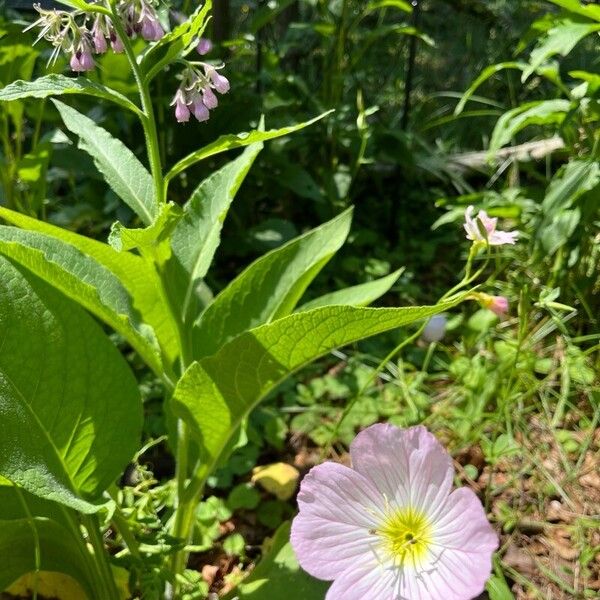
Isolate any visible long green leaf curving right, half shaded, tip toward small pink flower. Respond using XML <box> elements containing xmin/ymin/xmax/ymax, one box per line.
<box><xmin>171</xmin><ymin>300</ymin><xmax>460</xmax><ymax>478</ymax></box>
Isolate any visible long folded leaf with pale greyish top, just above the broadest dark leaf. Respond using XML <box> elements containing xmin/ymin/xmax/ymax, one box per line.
<box><xmin>0</xmin><ymin>225</ymin><xmax>162</xmax><ymax>373</ymax></box>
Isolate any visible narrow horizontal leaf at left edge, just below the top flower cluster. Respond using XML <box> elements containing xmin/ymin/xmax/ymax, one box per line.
<box><xmin>0</xmin><ymin>73</ymin><xmax>141</xmax><ymax>115</ymax></box>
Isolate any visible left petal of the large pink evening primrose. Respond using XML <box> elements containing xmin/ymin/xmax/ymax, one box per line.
<box><xmin>291</xmin><ymin>462</ymin><xmax>385</xmax><ymax>580</ymax></box>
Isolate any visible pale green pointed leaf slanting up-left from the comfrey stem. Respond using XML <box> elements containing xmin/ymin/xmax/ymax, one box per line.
<box><xmin>53</xmin><ymin>100</ymin><xmax>158</xmax><ymax>225</ymax></box>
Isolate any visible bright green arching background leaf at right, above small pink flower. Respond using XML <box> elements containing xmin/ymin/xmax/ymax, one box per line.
<box><xmin>490</xmin><ymin>99</ymin><xmax>571</xmax><ymax>153</ymax></box>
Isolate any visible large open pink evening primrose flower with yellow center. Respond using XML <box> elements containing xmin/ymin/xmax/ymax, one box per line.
<box><xmin>291</xmin><ymin>424</ymin><xmax>498</xmax><ymax>600</ymax></box>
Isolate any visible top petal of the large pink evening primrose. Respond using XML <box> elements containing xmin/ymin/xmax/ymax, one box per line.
<box><xmin>350</xmin><ymin>424</ymin><xmax>454</xmax><ymax>513</ymax></box>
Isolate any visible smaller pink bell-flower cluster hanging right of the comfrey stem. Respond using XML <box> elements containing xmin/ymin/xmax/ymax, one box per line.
<box><xmin>171</xmin><ymin>63</ymin><xmax>230</xmax><ymax>123</ymax></box>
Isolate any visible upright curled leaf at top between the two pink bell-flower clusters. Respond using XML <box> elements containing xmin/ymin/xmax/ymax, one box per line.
<box><xmin>140</xmin><ymin>0</ymin><xmax>212</xmax><ymax>81</ymax></box>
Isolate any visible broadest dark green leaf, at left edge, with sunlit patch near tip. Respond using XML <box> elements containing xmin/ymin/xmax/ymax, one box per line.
<box><xmin>0</xmin><ymin>258</ymin><xmax>142</xmax><ymax>512</ymax></box>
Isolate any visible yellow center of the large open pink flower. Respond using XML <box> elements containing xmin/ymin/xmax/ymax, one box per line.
<box><xmin>377</xmin><ymin>508</ymin><xmax>432</xmax><ymax>567</ymax></box>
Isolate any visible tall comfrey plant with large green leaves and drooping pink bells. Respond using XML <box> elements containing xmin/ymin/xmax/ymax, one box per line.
<box><xmin>0</xmin><ymin>0</ymin><xmax>516</xmax><ymax>600</ymax></box>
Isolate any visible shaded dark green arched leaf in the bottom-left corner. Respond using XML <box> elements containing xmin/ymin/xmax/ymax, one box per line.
<box><xmin>0</xmin><ymin>517</ymin><xmax>100</xmax><ymax>600</ymax></box>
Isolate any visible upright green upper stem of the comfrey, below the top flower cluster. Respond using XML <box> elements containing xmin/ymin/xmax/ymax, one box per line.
<box><xmin>110</xmin><ymin>0</ymin><xmax>165</xmax><ymax>205</ymax></box>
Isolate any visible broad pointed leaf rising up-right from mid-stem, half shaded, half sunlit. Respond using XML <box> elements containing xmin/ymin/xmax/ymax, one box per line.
<box><xmin>193</xmin><ymin>210</ymin><xmax>352</xmax><ymax>358</ymax></box>
